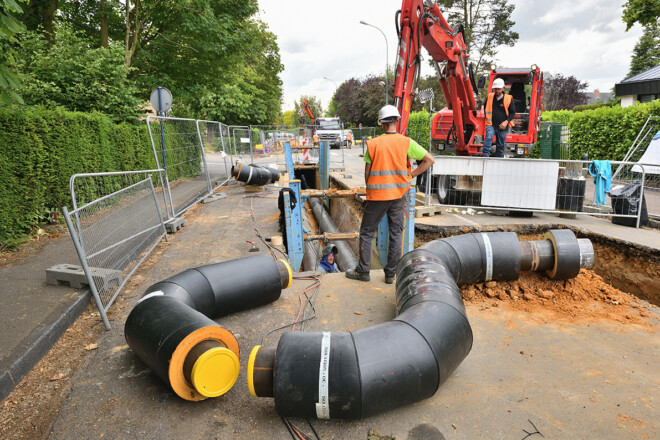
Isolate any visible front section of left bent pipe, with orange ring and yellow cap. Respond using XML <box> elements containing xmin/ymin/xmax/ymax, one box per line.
<box><xmin>124</xmin><ymin>292</ymin><xmax>239</xmax><ymax>401</ymax></box>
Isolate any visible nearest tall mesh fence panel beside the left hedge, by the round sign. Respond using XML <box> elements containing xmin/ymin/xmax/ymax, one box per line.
<box><xmin>147</xmin><ymin>116</ymin><xmax>212</xmax><ymax>218</ymax></box>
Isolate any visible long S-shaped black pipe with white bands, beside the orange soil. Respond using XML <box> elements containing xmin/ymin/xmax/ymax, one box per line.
<box><xmin>248</xmin><ymin>230</ymin><xmax>593</xmax><ymax>419</ymax></box>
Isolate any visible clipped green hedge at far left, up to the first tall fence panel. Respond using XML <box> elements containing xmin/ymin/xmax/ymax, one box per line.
<box><xmin>0</xmin><ymin>108</ymin><xmax>155</xmax><ymax>249</ymax></box>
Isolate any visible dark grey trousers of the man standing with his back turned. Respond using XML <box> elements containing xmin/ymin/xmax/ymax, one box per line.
<box><xmin>355</xmin><ymin>193</ymin><xmax>408</xmax><ymax>277</ymax></box>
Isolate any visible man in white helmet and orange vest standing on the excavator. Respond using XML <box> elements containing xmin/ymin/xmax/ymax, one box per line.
<box><xmin>481</xmin><ymin>78</ymin><xmax>516</xmax><ymax>157</ymax></box>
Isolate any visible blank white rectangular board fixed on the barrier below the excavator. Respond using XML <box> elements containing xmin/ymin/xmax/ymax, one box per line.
<box><xmin>481</xmin><ymin>159</ymin><xmax>559</xmax><ymax>209</ymax></box>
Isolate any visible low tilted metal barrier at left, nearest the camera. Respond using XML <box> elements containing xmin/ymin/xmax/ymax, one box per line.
<box><xmin>62</xmin><ymin>174</ymin><xmax>167</xmax><ymax>330</ymax></box>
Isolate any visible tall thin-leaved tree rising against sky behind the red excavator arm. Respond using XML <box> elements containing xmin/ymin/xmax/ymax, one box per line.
<box><xmin>442</xmin><ymin>0</ymin><xmax>518</xmax><ymax>74</ymax></box>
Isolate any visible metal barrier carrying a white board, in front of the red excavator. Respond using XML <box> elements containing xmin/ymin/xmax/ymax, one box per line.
<box><xmin>423</xmin><ymin>156</ymin><xmax>660</xmax><ymax>227</ymax></box>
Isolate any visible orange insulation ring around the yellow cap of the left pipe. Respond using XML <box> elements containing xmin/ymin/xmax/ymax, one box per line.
<box><xmin>168</xmin><ymin>325</ymin><xmax>239</xmax><ymax>402</ymax></box>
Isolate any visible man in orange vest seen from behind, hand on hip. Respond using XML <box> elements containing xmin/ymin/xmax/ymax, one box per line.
<box><xmin>346</xmin><ymin>105</ymin><xmax>435</xmax><ymax>284</ymax></box>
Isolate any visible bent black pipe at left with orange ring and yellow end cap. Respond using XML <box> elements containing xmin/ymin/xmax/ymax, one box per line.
<box><xmin>124</xmin><ymin>254</ymin><xmax>293</xmax><ymax>401</ymax></box>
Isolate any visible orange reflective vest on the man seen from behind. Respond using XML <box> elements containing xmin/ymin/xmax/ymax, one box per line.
<box><xmin>367</xmin><ymin>133</ymin><xmax>412</xmax><ymax>200</ymax></box>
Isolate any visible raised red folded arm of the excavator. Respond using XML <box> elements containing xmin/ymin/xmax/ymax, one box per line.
<box><xmin>394</xmin><ymin>0</ymin><xmax>479</xmax><ymax>155</ymax></box>
